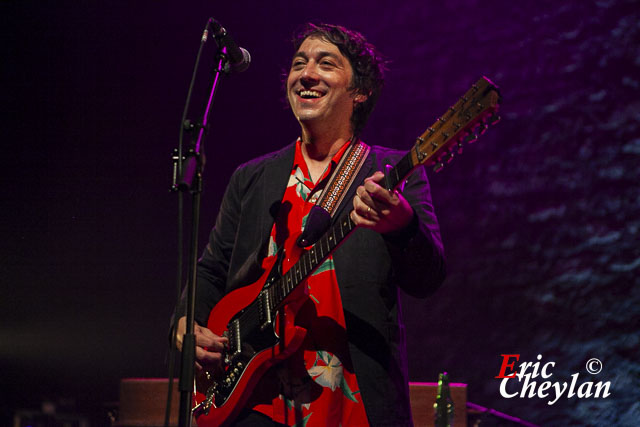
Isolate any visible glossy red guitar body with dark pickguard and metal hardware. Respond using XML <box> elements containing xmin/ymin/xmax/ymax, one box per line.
<box><xmin>194</xmin><ymin>252</ymin><xmax>307</xmax><ymax>427</ymax></box>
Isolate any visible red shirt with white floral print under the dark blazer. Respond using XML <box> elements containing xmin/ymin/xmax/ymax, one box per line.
<box><xmin>253</xmin><ymin>140</ymin><xmax>369</xmax><ymax>427</ymax></box>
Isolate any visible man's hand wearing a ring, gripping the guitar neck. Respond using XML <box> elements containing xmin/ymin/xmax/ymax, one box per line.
<box><xmin>351</xmin><ymin>171</ymin><xmax>413</xmax><ymax>233</ymax></box>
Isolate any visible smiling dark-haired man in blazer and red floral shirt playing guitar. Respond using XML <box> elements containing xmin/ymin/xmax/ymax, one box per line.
<box><xmin>177</xmin><ymin>24</ymin><xmax>444</xmax><ymax>426</ymax></box>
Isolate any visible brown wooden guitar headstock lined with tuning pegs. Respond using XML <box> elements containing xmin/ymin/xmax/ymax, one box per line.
<box><xmin>411</xmin><ymin>77</ymin><xmax>501</xmax><ymax>172</ymax></box>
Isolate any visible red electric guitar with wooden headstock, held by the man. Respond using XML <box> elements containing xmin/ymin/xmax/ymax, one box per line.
<box><xmin>192</xmin><ymin>77</ymin><xmax>501</xmax><ymax>427</ymax></box>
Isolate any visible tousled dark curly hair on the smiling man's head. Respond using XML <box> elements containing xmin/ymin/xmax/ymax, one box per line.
<box><xmin>292</xmin><ymin>23</ymin><xmax>386</xmax><ymax>136</ymax></box>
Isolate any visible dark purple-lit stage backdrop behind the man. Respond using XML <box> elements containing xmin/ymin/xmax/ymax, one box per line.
<box><xmin>0</xmin><ymin>0</ymin><xmax>640</xmax><ymax>425</ymax></box>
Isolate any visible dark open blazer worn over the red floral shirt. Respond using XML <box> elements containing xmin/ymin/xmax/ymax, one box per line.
<box><xmin>180</xmin><ymin>144</ymin><xmax>445</xmax><ymax>426</ymax></box>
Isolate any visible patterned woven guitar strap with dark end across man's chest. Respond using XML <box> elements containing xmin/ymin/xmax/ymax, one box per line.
<box><xmin>297</xmin><ymin>140</ymin><xmax>371</xmax><ymax>247</ymax></box>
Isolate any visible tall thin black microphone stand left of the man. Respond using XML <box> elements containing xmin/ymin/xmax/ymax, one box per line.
<box><xmin>172</xmin><ymin>21</ymin><xmax>234</xmax><ymax>427</ymax></box>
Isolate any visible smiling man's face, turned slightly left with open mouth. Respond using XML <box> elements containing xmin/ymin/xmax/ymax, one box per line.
<box><xmin>287</xmin><ymin>37</ymin><xmax>362</xmax><ymax>132</ymax></box>
